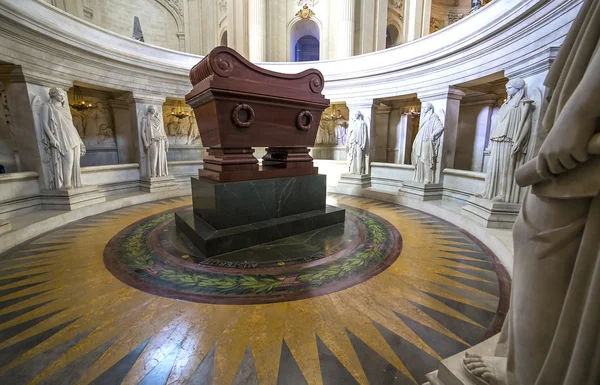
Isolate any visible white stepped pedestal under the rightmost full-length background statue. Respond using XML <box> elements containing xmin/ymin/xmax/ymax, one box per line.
<box><xmin>462</xmin><ymin>197</ymin><xmax>521</xmax><ymax>229</ymax></box>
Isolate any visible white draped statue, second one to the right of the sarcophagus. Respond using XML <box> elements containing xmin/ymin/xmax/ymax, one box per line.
<box><xmin>411</xmin><ymin>103</ymin><xmax>444</xmax><ymax>183</ymax></box>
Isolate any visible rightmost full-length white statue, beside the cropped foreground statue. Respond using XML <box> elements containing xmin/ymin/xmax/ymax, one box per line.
<box><xmin>477</xmin><ymin>78</ymin><xmax>533</xmax><ymax>203</ymax></box>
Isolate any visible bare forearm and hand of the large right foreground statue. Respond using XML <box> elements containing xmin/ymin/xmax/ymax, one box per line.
<box><xmin>537</xmin><ymin>43</ymin><xmax>600</xmax><ymax>178</ymax></box>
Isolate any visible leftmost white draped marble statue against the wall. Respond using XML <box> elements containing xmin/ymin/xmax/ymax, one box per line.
<box><xmin>39</xmin><ymin>87</ymin><xmax>86</xmax><ymax>190</ymax></box>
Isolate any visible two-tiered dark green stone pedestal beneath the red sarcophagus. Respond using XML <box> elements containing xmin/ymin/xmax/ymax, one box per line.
<box><xmin>175</xmin><ymin>175</ymin><xmax>345</xmax><ymax>257</ymax></box>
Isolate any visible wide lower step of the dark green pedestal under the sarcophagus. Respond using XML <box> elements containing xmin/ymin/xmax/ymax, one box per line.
<box><xmin>175</xmin><ymin>206</ymin><xmax>346</xmax><ymax>257</ymax></box>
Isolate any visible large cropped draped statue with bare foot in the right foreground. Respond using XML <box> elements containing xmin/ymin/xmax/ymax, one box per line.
<box><xmin>463</xmin><ymin>0</ymin><xmax>600</xmax><ymax>385</ymax></box>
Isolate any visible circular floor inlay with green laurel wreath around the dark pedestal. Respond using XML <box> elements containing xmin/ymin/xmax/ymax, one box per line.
<box><xmin>104</xmin><ymin>208</ymin><xmax>402</xmax><ymax>304</ymax></box>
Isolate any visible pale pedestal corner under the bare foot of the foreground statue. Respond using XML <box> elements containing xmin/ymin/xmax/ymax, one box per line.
<box><xmin>423</xmin><ymin>334</ymin><xmax>499</xmax><ymax>385</ymax></box>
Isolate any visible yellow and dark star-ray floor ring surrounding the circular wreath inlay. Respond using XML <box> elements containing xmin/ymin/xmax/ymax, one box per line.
<box><xmin>0</xmin><ymin>194</ymin><xmax>510</xmax><ymax>385</ymax></box>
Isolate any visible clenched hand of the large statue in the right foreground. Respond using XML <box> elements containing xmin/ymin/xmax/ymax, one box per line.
<box><xmin>537</xmin><ymin>109</ymin><xmax>597</xmax><ymax>178</ymax></box>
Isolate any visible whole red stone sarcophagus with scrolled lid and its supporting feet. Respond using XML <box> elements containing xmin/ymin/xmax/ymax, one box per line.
<box><xmin>185</xmin><ymin>47</ymin><xmax>329</xmax><ymax>182</ymax></box>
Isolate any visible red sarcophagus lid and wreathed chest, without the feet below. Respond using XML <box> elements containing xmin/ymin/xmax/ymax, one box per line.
<box><xmin>186</xmin><ymin>47</ymin><xmax>329</xmax><ymax>148</ymax></box>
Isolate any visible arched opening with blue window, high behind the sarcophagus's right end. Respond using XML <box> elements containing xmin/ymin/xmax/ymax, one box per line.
<box><xmin>290</xmin><ymin>19</ymin><xmax>321</xmax><ymax>62</ymax></box>
